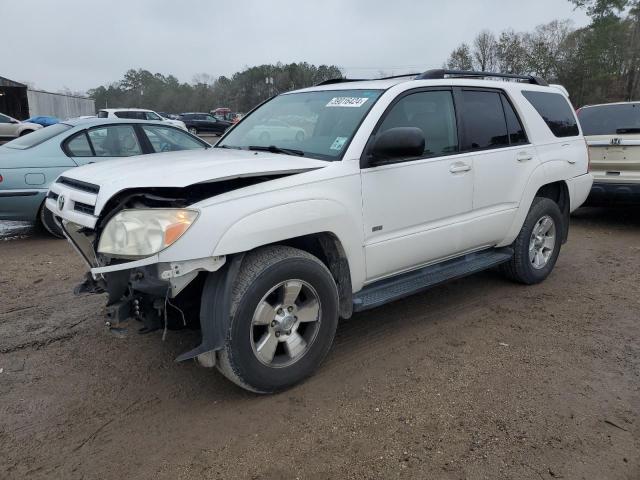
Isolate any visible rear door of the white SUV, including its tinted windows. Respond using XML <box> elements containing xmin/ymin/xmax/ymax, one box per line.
<box><xmin>456</xmin><ymin>88</ymin><xmax>539</xmax><ymax>247</ymax></box>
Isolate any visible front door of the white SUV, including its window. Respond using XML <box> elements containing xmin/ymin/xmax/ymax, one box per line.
<box><xmin>361</xmin><ymin>89</ymin><xmax>473</xmax><ymax>282</ymax></box>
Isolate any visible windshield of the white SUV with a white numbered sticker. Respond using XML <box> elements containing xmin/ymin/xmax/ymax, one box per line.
<box><xmin>216</xmin><ymin>90</ymin><xmax>382</xmax><ymax>160</ymax></box>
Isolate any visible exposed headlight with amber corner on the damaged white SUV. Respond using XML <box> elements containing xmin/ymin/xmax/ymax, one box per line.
<box><xmin>98</xmin><ymin>208</ymin><xmax>198</xmax><ymax>257</ymax></box>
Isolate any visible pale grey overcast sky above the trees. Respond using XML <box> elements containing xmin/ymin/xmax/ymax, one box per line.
<box><xmin>0</xmin><ymin>0</ymin><xmax>588</xmax><ymax>91</ymax></box>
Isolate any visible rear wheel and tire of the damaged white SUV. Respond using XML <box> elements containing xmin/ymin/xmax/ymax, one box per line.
<box><xmin>500</xmin><ymin>197</ymin><xmax>563</xmax><ymax>285</ymax></box>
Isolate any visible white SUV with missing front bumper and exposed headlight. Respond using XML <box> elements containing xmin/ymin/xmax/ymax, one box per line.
<box><xmin>47</xmin><ymin>70</ymin><xmax>592</xmax><ymax>392</ymax></box>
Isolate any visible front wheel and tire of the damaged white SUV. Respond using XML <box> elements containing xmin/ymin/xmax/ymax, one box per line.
<box><xmin>216</xmin><ymin>246</ymin><xmax>338</xmax><ymax>393</ymax></box>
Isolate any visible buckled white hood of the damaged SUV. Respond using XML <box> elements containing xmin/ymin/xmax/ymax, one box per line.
<box><xmin>57</xmin><ymin>148</ymin><xmax>329</xmax><ymax>203</ymax></box>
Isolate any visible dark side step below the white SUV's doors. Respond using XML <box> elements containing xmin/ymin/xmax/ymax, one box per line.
<box><xmin>353</xmin><ymin>247</ymin><xmax>513</xmax><ymax>312</ymax></box>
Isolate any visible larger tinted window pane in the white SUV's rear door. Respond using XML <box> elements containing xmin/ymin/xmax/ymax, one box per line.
<box><xmin>460</xmin><ymin>90</ymin><xmax>509</xmax><ymax>150</ymax></box>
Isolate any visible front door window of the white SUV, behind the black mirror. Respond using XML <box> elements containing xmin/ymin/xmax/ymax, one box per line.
<box><xmin>377</xmin><ymin>90</ymin><xmax>458</xmax><ymax>157</ymax></box>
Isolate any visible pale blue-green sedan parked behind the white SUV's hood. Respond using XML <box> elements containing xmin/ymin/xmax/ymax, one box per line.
<box><xmin>0</xmin><ymin>119</ymin><xmax>210</xmax><ymax>237</ymax></box>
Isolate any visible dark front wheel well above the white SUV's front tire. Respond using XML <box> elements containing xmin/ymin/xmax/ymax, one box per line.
<box><xmin>260</xmin><ymin>232</ymin><xmax>353</xmax><ymax>318</ymax></box>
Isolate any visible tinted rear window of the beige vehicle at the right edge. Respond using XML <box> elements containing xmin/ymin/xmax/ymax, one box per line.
<box><xmin>578</xmin><ymin>103</ymin><xmax>640</xmax><ymax>135</ymax></box>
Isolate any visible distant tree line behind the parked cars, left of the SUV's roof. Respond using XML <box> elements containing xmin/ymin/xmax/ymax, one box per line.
<box><xmin>88</xmin><ymin>63</ymin><xmax>342</xmax><ymax>113</ymax></box>
